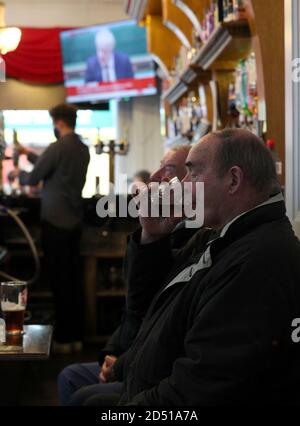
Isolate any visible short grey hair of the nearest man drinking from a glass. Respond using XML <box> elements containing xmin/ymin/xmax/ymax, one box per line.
<box><xmin>211</xmin><ymin>129</ymin><xmax>278</xmax><ymax>194</ymax></box>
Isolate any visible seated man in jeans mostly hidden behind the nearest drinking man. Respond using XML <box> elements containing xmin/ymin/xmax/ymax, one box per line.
<box><xmin>58</xmin><ymin>145</ymin><xmax>197</xmax><ymax>405</ymax></box>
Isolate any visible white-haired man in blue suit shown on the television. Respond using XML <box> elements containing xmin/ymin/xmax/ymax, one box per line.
<box><xmin>85</xmin><ymin>28</ymin><xmax>134</xmax><ymax>83</ymax></box>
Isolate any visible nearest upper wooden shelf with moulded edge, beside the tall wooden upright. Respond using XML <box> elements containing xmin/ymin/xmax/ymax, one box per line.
<box><xmin>191</xmin><ymin>19</ymin><xmax>251</xmax><ymax>70</ymax></box>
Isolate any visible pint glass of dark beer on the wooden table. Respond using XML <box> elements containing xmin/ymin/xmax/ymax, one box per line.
<box><xmin>0</xmin><ymin>281</ymin><xmax>27</xmax><ymax>335</ymax></box>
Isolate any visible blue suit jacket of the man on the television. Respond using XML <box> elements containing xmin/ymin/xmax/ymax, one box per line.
<box><xmin>85</xmin><ymin>52</ymin><xmax>134</xmax><ymax>83</ymax></box>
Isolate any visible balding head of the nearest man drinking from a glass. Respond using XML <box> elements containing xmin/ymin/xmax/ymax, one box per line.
<box><xmin>185</xmin><ymin>129</ymin><xmax>277</xmax><ymax>228</ymax></box>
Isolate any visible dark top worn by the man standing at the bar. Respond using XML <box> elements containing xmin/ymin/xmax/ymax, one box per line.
<box><xmin>20</xmin><ymin>133</ymin><xmax>90</xmax><ymax>229</ymax></box>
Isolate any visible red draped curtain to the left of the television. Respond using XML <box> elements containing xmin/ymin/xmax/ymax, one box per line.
<box><xmin>4</xmin><ymin>28</ymin><xmax>73</xmax><ymax>84</ymax></box>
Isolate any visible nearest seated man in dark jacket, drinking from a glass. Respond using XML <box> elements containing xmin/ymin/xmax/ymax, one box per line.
<box><xmin>87</xmin><ymin>130</ymin><xmax>300</xmax><ymax>406</ymax></box>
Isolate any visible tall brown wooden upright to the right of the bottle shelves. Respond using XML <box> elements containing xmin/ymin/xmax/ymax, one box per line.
<box><xmin>245</xmin><ymin>0</ymin><xmax>285</xmax><ymax>185</ymax></box>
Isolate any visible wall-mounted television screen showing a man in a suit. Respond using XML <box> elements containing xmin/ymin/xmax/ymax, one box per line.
<box><xmin>60</xmin><ymin>21</ymin><xmax>156</xmax><ymax>103</ymax></box>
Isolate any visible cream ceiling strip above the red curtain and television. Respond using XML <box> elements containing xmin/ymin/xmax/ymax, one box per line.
<box><xmin>4</xmin><ymin>0</ymin><xmax>128</xmax><ymax>27</ymax></box>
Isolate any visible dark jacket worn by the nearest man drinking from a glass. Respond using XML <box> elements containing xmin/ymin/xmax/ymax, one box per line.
<box><xmin>115</xmin><ymin>195</ymin><xmax>300</xmax><ymax>406</ymax></box>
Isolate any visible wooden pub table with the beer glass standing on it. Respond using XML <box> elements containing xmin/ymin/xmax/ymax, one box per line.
<box><xmin>0</xmin><ymin>325</ymin><xmax>53</xmax><ymax>406</ymax></box>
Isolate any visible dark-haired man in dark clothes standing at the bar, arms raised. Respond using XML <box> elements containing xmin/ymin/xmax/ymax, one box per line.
<box><xmin>15</xmin><ymin>104</ymin><xmax>90</xmax><ymax>353</ymax></box>
